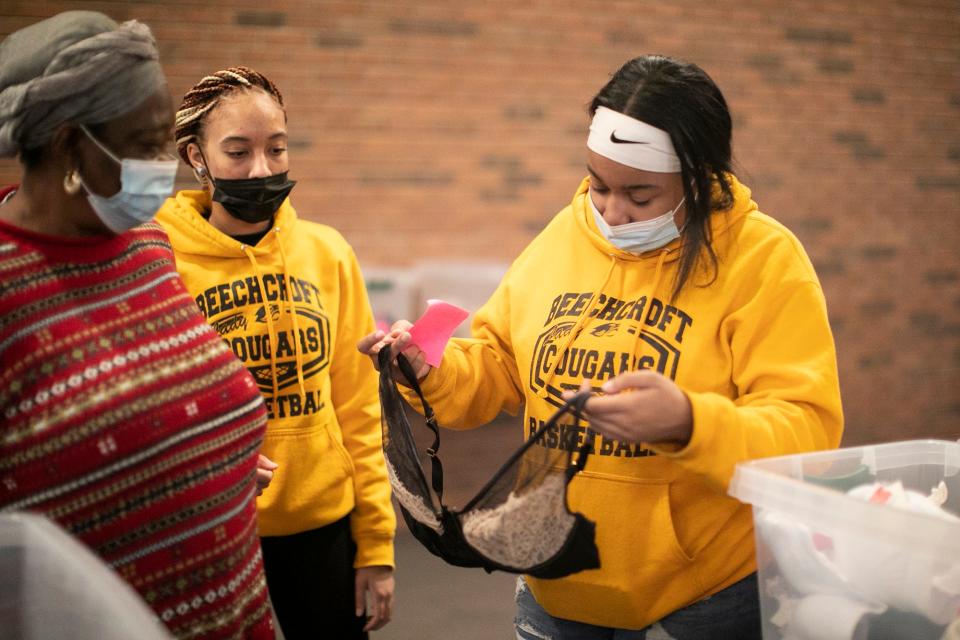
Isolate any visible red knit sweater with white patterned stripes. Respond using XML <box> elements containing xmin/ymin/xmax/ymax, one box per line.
<box><xmin>0</xmin><ymin>204</ymin><xmax>274</xmax><ymax>638</ymax></box>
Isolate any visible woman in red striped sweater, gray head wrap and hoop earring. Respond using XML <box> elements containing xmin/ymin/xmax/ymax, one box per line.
<box><xmin>0</xmin><ymin>11</ymin><xmax>274</xmax><ymax>639</ymax></box>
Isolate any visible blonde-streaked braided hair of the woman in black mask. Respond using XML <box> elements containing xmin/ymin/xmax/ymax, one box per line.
<box><xmin>176</xmin><ymin>67</ymin><xmax>283</xmax><ymax>165</ymax></box>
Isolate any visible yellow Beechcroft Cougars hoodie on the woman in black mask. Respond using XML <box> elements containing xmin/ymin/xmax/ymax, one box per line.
<box><xmin>157</xmin><ymin>191</ymin><xmax>396</xmax><ymax>567</ymax></box>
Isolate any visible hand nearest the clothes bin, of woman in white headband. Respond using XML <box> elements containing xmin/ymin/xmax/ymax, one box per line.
<box><xmin>564</xmin><ymin>369</ymin><xmax>693</xmax><ymax>445</ymax></box>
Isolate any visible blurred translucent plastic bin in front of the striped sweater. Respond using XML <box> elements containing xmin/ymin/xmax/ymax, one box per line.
<box><xmin>0</xmin><ymin>512</ymin><xmax>171</xmax><ymax>640</ymax></box>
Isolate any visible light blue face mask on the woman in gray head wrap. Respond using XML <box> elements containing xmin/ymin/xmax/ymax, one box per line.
<box><xmin>80</xmin><ymin>125</ymin><xmax>177</xmax><ymax>233</ymax></box>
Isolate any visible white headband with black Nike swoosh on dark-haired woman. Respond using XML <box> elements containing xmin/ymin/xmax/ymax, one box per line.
<box><xmin>587</xmin><ymin>107</ymin><xmax>680</xmax><ymax>173</ymax></box>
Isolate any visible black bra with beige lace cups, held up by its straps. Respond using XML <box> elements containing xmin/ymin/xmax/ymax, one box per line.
<box><xmin>378</xmin><ymin>349</ymin><xmax>600</xmax><ymax>578</ymax></box>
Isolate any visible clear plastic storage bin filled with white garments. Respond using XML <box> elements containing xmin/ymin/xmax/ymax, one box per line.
<box><xmin>729</xmin><ymin>440</ymin><xmax>960</xmax><ymax>640</ymax></box>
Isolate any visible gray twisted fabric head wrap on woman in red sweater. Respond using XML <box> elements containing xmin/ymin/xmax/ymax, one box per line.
<box><xmin>0</xmin><ymin>11</ymin><xmax>165</xmax><ymax>157</ymax></box>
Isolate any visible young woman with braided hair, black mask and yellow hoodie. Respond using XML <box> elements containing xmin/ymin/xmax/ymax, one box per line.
<box><xmin>157</xmin><ymin>67</ymin><xmax>396</xmax><ymax>640</ymax></box>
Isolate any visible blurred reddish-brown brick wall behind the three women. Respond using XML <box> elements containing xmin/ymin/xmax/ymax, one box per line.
<box><xmin>0</xmin><ymin>0</ymin><xmax>960</xmax><ymax>445</ymax></box>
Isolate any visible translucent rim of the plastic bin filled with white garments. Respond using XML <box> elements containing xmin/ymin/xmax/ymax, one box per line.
<box><xmin>728</xmin><ymin>440</ymin><xmax>960</xmax><ymax>558</ymax></box>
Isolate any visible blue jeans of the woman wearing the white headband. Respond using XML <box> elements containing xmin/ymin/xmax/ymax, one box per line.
<box><xmin>513</xmin><ymin>573</ymin><xmax>762</xmax><ymax>640</ymax></box>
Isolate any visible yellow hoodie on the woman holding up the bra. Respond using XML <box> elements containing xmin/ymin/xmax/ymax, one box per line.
<box><xmin>408</xmin><ymin>176</ymin><xmax>843</xmax><ymax>629</ymax></box>
